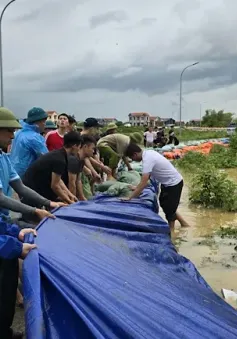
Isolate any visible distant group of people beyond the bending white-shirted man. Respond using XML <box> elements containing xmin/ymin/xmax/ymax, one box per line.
<box><xmin>144</xmin><ymin>126</ymin><xmax>179</xmax><ymax>148</ymax></box>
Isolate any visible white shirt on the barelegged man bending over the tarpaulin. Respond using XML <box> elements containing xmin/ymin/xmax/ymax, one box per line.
<box><xmin>142</xmin><ymin>150</ymin><xmax>183</xmax><ymax>187</ymax></box>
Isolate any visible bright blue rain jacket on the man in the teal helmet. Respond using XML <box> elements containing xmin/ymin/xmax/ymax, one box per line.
<box><xmin>10</xmin><ymin>123</ymin><xmax>48</xmax><ymax>178</ymax></box>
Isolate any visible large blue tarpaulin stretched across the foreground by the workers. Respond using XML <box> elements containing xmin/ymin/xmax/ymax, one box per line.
<box><xmin>23</xmin><ymin>188</ymin><xmax>237</xmax><ymax>339</ymax></box>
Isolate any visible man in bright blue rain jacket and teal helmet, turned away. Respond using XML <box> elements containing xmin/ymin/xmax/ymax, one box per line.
<box><xmin>10</xmin><ymin>107</ymin><xmax>48</xmax><ymax>178</ymax></box>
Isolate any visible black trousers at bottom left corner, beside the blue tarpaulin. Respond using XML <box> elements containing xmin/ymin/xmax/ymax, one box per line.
<box><xmin>0</xmin><ymin>258</ymin><xmax>18</xmax><ymax>339</ymax></box>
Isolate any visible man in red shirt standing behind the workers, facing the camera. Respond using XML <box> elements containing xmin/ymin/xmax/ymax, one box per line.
<box><xmin>45</xmin><ymin>113</ymin><xmax>69</xmax><ymax>151</ymax></box>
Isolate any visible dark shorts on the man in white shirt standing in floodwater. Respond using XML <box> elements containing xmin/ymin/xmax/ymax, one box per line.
<box><xmin>159</xmin><ymin>180</ymin><xmax>184</xmax><ymax>222</ymax></box>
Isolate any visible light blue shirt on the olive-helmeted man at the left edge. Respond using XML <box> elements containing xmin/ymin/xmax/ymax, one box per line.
<box><xmin>0</xmin><ymin>150</ymin><xmax>20</xmax><ymax>220</ymax></box>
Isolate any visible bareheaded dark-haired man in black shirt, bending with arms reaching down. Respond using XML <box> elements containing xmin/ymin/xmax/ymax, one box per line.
<box><xmin>23</xmin><ymin>132</ymin><xmax>81</xmax><ymax>204</ymax></box>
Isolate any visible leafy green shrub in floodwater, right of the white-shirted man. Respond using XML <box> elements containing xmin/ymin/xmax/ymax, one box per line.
<box><xmin>189</xmin><ymin>166</ymin><xmax>237</xmax><ymax>211</ymax></box>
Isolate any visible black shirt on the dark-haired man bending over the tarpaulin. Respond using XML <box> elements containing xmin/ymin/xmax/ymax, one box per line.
<box><xmin>22</xmin><ymin>148</ymin><xmax>68</xmax><ymax>201</ymax></box>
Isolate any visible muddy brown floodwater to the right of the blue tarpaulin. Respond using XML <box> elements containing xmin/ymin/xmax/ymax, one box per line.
<box><xmin>169</xmin><ymin>170</ymin><xmax>237</xmax><ymax>295</ymax></box>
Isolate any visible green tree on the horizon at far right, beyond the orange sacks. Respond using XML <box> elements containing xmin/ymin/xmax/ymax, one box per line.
<box><xmin>202</xmin><ymin>109</ymin><xmax>234</xmax><ymax>127</ymax></box>
